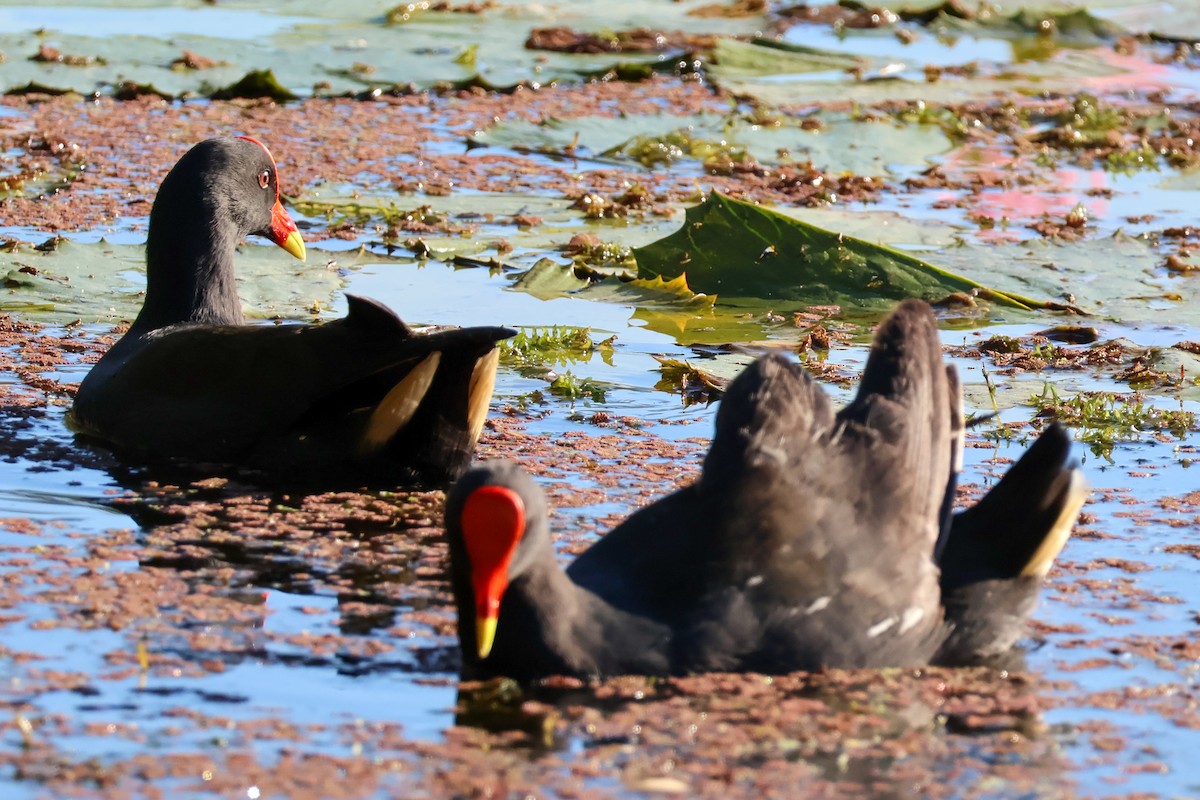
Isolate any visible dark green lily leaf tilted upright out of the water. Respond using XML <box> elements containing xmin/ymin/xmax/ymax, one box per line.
<box><xmin>634</xmin><ymin>192</ymin><xmax>1045</xmax><ymax>308</ymax></box>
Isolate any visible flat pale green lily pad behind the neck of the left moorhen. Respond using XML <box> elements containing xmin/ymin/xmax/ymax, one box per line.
<box><xmin>0</xmin><ymin>240</ymin><xmax>342</xmax><ymax>324</ymax></box>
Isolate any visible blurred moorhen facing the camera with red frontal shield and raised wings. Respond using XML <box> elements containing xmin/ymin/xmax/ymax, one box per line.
<box><xmin>446</xmin><ymin>300</ymin><xmax>1085</xmax><ymax>680</ymax></box>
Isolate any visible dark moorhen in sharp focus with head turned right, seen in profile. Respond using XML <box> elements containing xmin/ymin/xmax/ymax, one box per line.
<box><xmin>70</xmin><ymin>138</ymin><xmax>515</xmax><ymax>485</ymax></box>
